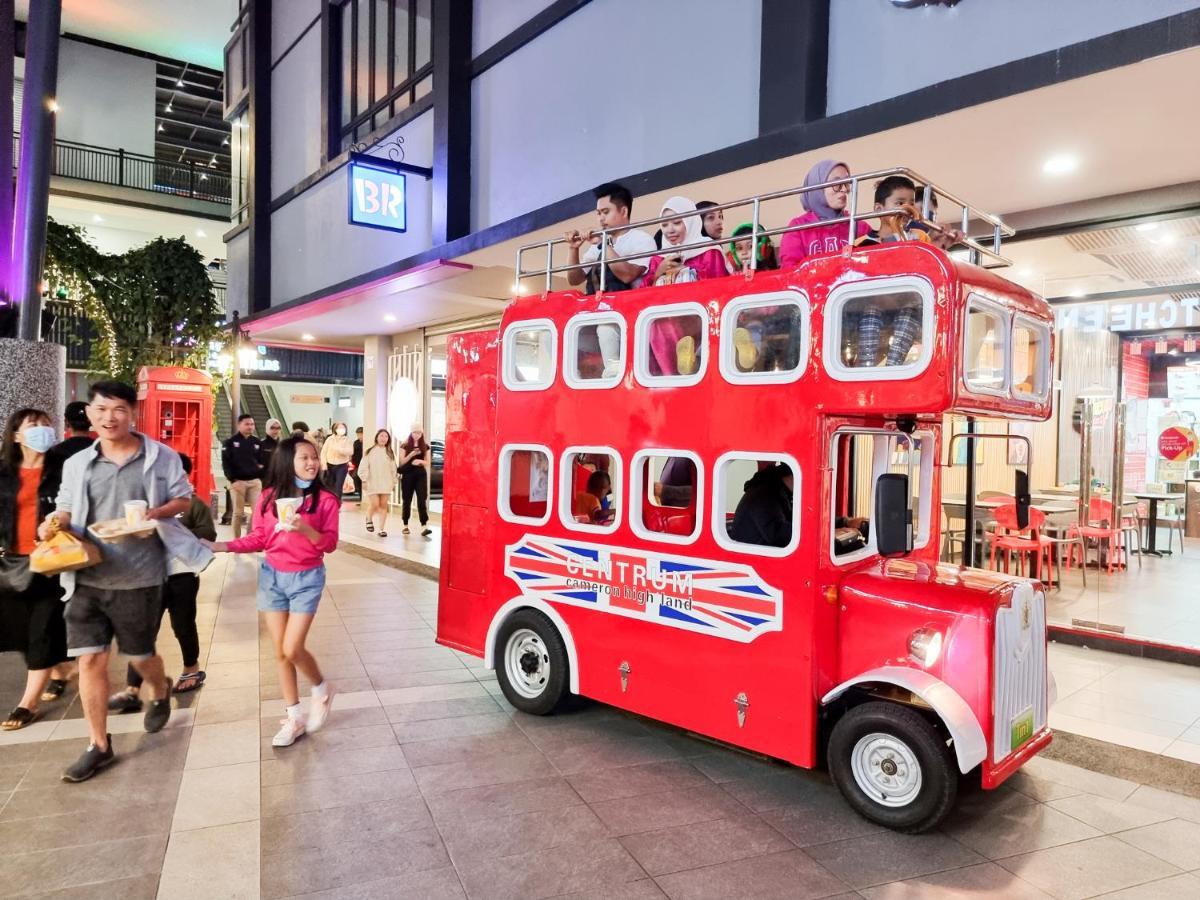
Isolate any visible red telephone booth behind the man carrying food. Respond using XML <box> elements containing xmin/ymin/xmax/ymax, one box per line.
<box><xmin>138</xmin><ymin>366</ymin><xmax>214</xmax><ymax>499</ymax></box>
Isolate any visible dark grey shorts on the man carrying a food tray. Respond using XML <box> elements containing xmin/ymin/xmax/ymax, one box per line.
<box><xmin>65</xmin><ymin>584</ymin><xmax>162</xmax><ymax>659</ymax></box>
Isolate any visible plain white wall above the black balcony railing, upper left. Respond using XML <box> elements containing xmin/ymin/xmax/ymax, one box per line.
<box><xmin>56</xmin><ymin>38</ymin><xmax>157</xmax><ymax>156</ymax></box>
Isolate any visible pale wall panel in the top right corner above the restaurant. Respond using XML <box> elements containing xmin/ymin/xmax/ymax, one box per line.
<box><xmin>827</xmin><ymin>0</ymin><xmax>1200</xmax><ymax>115</ymax></box>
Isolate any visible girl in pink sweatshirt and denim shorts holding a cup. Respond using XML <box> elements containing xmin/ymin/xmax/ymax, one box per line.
<box><xmin>205</xmin><ymin>437</ymin><xmax>341</xmax><ymax>746</ymax></box>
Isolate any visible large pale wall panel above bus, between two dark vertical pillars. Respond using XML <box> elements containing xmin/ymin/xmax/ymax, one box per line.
<box><xmin>472</xmin><ymin>0</ymin><xmax>761</xmax><ymax>229</ymax></box>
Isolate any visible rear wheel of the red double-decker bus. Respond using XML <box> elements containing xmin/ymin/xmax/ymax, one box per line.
<box><xmin>496</xmin><ymin>610</ymin><xmax>569</xmax><ymax>715</ymax></box>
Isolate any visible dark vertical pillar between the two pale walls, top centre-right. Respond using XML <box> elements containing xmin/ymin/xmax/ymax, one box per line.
<box><xmin>758</xmin><ymin>0</ymin><xmax>829</xmax><ymax>134</ymax></box>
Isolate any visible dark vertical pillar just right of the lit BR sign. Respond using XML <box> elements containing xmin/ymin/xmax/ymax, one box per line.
<box><xmin>432</xmin><ymin>0</ymin><xmax>472</xmax><ymax>244</ymax></box>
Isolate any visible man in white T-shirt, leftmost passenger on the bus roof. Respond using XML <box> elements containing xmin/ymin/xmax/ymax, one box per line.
<box><xmin>566</xmin><ymin>182</ymin><xmax>658</xmax><ymax>378</ymax></box>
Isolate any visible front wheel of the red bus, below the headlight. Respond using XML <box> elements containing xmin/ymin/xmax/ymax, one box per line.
<box><xmin>829</xmin><ymin>702</ymin><xmax>959</xmax><ymax>834</ymax></box>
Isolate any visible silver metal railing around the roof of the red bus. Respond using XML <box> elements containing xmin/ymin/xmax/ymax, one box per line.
<box><xmin>515</xmin><ymin>166</ymin><xmax>1016</xmax><ymax>293</ymax></box>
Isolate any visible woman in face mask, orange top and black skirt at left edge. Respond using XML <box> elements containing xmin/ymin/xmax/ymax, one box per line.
<box><xmin>0</xmin><ymin>408</ymin><xmax>67</xmax><ymax>731</ymax></box>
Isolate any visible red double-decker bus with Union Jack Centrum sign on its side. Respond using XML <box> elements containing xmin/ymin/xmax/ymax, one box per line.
<box><xmin>437</xmin><ymin>173</ymin><xmax>1052</xmax><ymax>832</ymax></box>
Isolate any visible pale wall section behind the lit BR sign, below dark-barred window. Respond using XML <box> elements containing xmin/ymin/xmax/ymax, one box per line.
<box><xmin>271</xmin><ymin>110</ymin><xmax>433</xmax><ymax>305</ymax></box>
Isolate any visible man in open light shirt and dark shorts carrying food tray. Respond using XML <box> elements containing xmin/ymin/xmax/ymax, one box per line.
<box><xmin>38</xmin><ymin>382</ymin><xmax>212</xmax><ymax>782</ymax></box>
